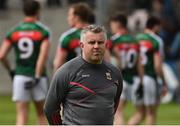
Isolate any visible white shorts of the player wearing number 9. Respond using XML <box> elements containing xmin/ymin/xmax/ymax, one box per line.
<box><xmin>12</xmin><ymin>75</ymin><xmax>48</xmax><ymax>102</ymax></box>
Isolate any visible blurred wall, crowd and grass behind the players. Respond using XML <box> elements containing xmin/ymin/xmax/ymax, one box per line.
<box><xmin>0</xmin><ymin>0</ymin><xmax>180</xmax><ymax>124</ymax></box>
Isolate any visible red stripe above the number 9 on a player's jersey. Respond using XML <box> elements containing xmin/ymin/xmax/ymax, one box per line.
<box><xmin>11</xmin><ymin>31</ymin><xmax>42</xmax><ymax>42</ymax></box>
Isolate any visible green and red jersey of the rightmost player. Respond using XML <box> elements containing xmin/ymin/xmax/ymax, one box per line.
<box><xmin>137</xmin><ymin>33</ymin><xmax>159</xmax><ymax>77</ymax></box>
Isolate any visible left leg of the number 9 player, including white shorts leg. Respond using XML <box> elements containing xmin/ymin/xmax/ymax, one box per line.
<box><xmin>12</xmin><ymin>75</ymin><xmax>31</xmax><ymax>125</ymax></box>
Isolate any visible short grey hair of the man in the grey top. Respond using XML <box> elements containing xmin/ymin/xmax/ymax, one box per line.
<box><xmin>80</xmin><ymin>25</ymin><xmax>107</xmax><ymax>42</ymax></box>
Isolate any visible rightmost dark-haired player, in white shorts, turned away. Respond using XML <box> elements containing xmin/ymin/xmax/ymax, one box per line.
<box><xmin>129</xmin><ymin>17</ymin><xmax>167</xmax><ymax>125</ymax></box>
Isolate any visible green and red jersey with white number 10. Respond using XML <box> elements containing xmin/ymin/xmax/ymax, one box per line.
<box><xmin>112</xmin><ymin>34</ymin><xmax>140</xmax><ymax>84</ymax></box>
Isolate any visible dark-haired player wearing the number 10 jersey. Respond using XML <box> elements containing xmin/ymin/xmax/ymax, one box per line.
<box><xmin>110</xmin><ymin>12</ymin><xmax>143</xmax><ymax>125</ymax></box>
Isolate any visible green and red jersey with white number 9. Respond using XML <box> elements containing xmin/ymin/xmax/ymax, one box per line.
<box><xmin>5</xmin><ymin>20</ymin><xmax>50</xmax><ymax>77</ymax></box>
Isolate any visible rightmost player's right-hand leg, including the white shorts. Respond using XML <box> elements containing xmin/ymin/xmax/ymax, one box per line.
<box><xmin>144</xmin><ymin>76</ymin><xmax>158</xmax><ymax>125</ymax></box>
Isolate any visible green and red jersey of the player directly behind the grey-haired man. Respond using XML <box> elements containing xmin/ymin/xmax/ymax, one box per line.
<box><xmin>59</xmin><ymin>28</ymin><xmax>82</xmax><ymax>61</ymax></box>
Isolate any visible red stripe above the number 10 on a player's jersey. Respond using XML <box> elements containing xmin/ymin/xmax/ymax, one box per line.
<box><xmin>115</xmin><ymin>43</ymin><xmax>139</xmax><ymax>51</ymax></box>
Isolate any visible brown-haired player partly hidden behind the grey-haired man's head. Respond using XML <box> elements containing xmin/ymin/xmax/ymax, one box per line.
<box><xmin>54</xmin><ymin>3</ymin><xmax>95</xmax><ymax>71</ymax></box>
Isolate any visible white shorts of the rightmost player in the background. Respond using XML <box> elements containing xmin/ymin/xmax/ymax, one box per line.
<box><xmin>133</xmin><ymin>75</ymin><xmax>159</xmax><ymax>106</ymax></box>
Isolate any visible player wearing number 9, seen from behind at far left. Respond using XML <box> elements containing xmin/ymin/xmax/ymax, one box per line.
<box><xmin>0</xmin><ymin>0</ymin><xmax>50</xmax><ymax>125</ymax></box>
